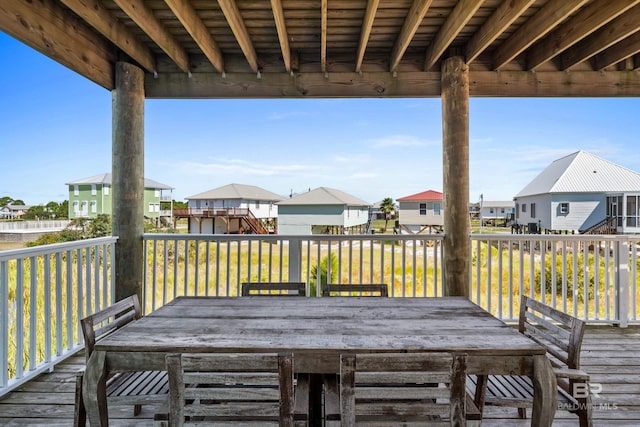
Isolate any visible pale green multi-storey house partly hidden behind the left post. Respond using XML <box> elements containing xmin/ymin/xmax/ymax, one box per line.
<box><xmin>65</xmin><ymin>173</ymin><xmax>173</xmax><ymax>220</ymax></box>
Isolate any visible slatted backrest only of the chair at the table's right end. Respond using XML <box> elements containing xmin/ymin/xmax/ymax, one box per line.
<box><xmin>518</xmin><ymin>295</ymin><xmax>585</xmax><ymax>369</ymax></box>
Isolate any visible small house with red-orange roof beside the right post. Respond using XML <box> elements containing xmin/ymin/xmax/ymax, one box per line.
<box><xmin>396</xmin><ymin>190</ymin><xmax>444</xmax><ymax>234</ymax></box>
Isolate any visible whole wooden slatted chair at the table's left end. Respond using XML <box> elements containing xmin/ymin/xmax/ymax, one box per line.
<box><xmin>73</xmin><ymin>295</ymin><xmax>169</xmax><ymax>426</ymax></box>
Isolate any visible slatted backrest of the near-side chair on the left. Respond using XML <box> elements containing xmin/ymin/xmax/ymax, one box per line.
<box><xmin>166</xmin><ymin>353</ymin><xmax>294</xmax><ymax>427</ymax></box>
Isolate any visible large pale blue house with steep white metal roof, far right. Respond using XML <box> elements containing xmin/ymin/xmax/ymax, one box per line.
<box><xmin>514</xmin><ymin>151</ymin><xmax>640</xmax><ymax>233</ymax></box>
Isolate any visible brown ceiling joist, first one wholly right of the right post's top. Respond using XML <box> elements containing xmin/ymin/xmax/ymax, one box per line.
<box><xmin>493</xmin><ymin>0</ymin><xmax>589</xmax><ymax>70</ymax></box>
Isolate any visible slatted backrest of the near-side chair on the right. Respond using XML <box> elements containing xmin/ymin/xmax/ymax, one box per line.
<box><xmin>340</xmin><ymin>352</ymin><xmax>467</xmax><ymax>426</ymax></box>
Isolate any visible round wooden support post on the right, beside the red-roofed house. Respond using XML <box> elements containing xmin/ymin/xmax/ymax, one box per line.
<box><xmin>442</xmin><ymin>56</ymin><xmax>471</xmax><ymax>297</ymax></box>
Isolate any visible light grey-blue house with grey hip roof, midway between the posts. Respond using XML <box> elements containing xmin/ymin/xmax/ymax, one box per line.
<box><xmin>278</xmin><ymin>187</ymin><xmax>369</xmax><ymax>235</ymax></box>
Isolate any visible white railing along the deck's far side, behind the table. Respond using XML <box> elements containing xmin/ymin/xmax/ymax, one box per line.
<box><xmin>144</xmin><ymin>234</ymin><xmax>640</xmax><ymax>326</ymax></box>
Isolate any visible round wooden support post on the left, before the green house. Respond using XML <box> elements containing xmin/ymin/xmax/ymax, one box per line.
<box><xmin>112</xmin><ymin>62</ymin><xmax>144</xmax><ymax>301</ymax></box>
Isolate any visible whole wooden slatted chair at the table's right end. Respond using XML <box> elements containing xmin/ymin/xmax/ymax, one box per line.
<box><xmin>468</xmin><ymin>296</ymin><xmax>593</xmax><ymax>427</ymax></box>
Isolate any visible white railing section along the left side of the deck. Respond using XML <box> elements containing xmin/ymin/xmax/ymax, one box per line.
<box><xmin>0</xmin><ymin>237</ymin><xmax>117</xmax><ymax>396</ymax></box>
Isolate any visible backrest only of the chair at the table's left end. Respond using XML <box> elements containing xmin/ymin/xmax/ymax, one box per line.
<box><xmin>80</xmin><ymin>294</ymin><xmax>142</xmax><ymax>360</ymax></box>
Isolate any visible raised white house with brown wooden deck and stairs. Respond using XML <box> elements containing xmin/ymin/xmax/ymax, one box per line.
<box><xmin>185</xmin><ymin>184</ymin><xmax>284</xmax><ymax>234</ymax></box>
